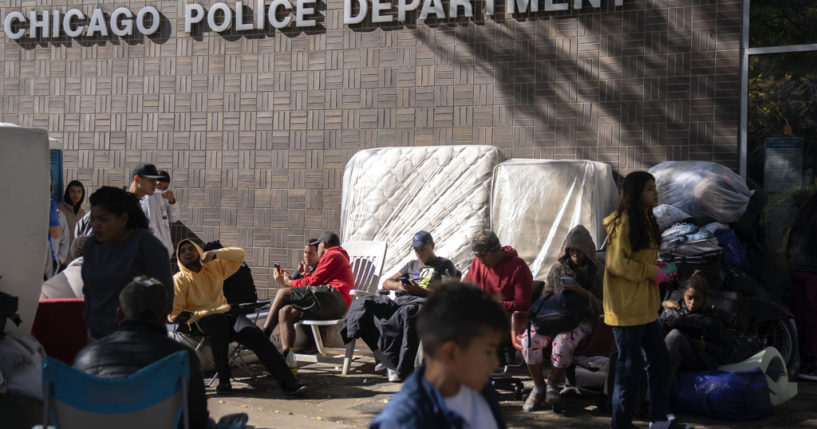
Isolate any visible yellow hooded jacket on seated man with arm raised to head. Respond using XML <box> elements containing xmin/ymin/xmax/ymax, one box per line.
<box><xmin>168</xmin><ymin>240</ymin><xmax>241</xmax><ymax>322</ymax></box>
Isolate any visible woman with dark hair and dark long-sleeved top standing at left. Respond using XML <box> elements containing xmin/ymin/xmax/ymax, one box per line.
<box><xmin>82</xmin><ymin>186</ymin><xmax>173</xmax><ymax>341</ymax></box>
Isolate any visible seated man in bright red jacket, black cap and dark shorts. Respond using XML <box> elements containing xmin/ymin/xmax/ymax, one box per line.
<box><xmin>264</xmin><ymin>231</ymin><xmax>355</xmax><ymax>365</ymax></box>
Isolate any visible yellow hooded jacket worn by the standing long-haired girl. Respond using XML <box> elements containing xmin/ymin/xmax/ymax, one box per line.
<box><xmin>602</xmin><ymin>212</ymin><xmax>661</xmax><ymax>326</ymax></box>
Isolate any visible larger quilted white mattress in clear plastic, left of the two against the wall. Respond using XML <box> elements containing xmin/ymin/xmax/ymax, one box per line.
<box><xmin>340</xmin><ymin>145</ymin><xmax>505</xmax><ymax>279</ymax></box>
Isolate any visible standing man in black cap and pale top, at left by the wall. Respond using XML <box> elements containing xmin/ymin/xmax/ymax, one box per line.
<box><xmin>128</xmin><ymin>162</ymin><xmax>176</xmax><ymax>257</ymax></box>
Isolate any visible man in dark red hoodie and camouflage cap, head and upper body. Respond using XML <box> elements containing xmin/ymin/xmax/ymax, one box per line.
<box><xmin>465</xmin><ymin>230</ymin><xmax>533</xmax><ymax>313</ymax></box>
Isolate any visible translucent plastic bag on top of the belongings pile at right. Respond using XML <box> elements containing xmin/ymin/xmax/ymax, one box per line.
<box><xmin>649</xmin><ymin>161</ymin><xmax>753</xmax><ymax>223</ymax></box>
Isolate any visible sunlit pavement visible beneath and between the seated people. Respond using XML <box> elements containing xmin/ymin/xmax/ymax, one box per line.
<box><xmin>207</xmin><ymin>357</ymin><xmax>817</xmax><ymax>429</ymax></box>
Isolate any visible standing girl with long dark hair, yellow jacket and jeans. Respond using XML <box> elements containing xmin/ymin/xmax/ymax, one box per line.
<box><xmin>603</xmin><ymin>171</ymin><xmax>676</xmax><ymax>429</ymax></box>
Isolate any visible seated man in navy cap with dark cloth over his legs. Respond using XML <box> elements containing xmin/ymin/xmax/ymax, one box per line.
<box><xmin>341</xmin><ymin>231</ymin><xmax>460</xmax><ymax>382</ymax></box>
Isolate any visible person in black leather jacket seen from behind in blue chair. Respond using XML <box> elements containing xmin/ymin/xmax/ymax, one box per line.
<box><xmin>74</xmin><ymin>276</ymin><xmax>212</xmax><ymax>428</ymax></box>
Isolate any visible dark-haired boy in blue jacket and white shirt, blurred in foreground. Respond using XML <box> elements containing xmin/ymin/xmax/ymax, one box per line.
<box><xmin>370</xmin><ymin>282</ymin><xmax>510</xmax><ymax>429</ymax></box>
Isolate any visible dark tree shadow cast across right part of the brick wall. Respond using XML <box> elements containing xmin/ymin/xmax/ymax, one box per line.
<box><xmin>412</xmin><ymin>1</ymin><xmax>724</xmax><ymax>159</ymax></box>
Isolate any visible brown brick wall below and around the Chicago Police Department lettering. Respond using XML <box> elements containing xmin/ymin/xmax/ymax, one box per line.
<box><xmin>0</xmin><ymin>0</ymin><xmax>742</xmax><ymax>294</ymax></box>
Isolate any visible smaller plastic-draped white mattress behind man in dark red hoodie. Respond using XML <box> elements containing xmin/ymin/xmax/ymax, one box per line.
<box><xmin>491</xmin><ymin>159</ymin><xmax>618</xmax><ymax>280</ymax></box>
